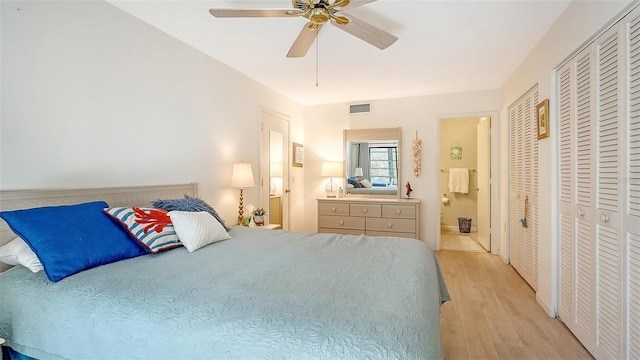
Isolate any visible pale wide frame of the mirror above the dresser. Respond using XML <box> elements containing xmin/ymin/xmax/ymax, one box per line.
<box><xmin>342</xmin><ymin>127</ymin><xmax>402</xmax><ymax>199</ymax></box>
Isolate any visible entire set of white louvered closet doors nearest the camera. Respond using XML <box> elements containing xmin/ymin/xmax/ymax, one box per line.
<box><xmin>557</xmin><ymin>4</ymin><xmax>640</xmax><ymax>359</ymax></box>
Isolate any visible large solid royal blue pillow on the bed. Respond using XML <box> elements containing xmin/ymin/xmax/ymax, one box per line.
<box><xmin>0</xmin><ymin>201</ymin><xmax>146</xmax><ymax>282</ymax></box>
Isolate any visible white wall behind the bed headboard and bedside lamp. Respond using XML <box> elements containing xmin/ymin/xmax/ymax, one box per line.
<box><xmin>0</xmin><ymin>1</ymin><xmax>304</xmax><ymax>223</ymax></box>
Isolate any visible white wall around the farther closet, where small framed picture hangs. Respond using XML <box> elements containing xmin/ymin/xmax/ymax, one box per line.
<box><xmin>501</xmin><ymin>0</ymin><xmax>630</xmax><ymax>316</ymax></box>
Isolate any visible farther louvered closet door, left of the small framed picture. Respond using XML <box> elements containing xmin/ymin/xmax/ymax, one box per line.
<box><xmin>509</xmin><ymin>86</ymin><xmax>538</xmax><ymax>290</ymax></box>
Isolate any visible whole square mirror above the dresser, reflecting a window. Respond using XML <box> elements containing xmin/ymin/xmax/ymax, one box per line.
<box><xmin>344</xmin><ymin>127</ymin><xmax>402</xmax><ymax>198</ymax></box>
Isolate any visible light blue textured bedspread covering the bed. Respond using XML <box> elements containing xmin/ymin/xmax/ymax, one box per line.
<box><xmin>0</xmin><ymin>227</ymin><xmax>448</xmax><ymax>359</ymax></box>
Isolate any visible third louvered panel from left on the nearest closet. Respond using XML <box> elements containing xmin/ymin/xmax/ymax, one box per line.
<box><xmin>593</xmin><ymin>27</ymin><xmax>624</xmax><ymax>359</ymax></box>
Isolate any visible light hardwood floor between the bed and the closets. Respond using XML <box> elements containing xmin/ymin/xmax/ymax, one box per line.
<box><xmin>436</xmin><ymin>251</ymin><xmax>593</xmax><ymax>360</ymax></box>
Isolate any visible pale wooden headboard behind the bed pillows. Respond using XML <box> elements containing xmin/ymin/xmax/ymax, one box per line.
<box><xmin>0</xmin><ymin>183</ymin><xmax>198</xmax><ymax>271</ymax></box>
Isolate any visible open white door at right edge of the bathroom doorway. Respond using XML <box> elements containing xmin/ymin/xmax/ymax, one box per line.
<box><xmin>476</xmin><ymin>117</ymin><xmax>491</xmax><ymax>251</ymax></box>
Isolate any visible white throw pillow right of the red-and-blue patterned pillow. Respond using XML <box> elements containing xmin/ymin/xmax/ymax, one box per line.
<box><xmin>169</xmin><ymin>211</ymin><xmax>231</xmax><ymax>252</ymax></box>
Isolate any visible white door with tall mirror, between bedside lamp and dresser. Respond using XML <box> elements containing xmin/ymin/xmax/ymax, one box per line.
<box><xmin>260</xmin><ymin>109</ymin><xmax>289</xmax><ymax>230</ymax></box>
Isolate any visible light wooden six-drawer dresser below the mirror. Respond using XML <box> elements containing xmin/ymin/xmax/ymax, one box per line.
<box><xmin>318</xmin><ymin>198</ymin><xmax>420</xmax><ymax>239</ymax></box>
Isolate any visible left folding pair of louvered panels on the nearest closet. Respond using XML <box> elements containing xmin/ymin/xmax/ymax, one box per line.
<box><xmin>558</xmin><ymin>43</ymin><xmax>595</xmax><ymax>351</ymax></box>
